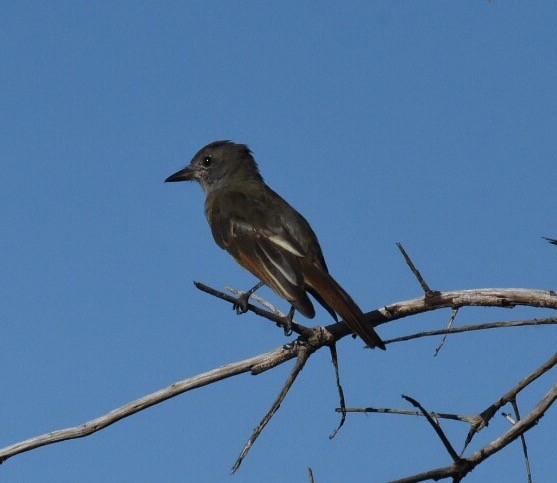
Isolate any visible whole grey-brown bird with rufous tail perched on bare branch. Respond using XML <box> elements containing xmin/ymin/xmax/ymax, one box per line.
<box><xmin>165</xmin><ymin>141</ymin><xmax>385</xmax><ymax>349</ymax></box>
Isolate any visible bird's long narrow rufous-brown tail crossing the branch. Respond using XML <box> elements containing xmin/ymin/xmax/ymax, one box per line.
<box><xmin>303</xmin><ymin>262</ymin><xmax>385</xmax><ymax>350</ymax></box>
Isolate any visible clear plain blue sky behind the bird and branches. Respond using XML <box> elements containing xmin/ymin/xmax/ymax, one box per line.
<box><xmin>0</xmin><ymin>1</ymin><xmax>557</xmax><ymax>482</ymax></box>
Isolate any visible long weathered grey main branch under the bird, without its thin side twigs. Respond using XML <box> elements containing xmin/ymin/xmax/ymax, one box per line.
<box><xmin>0</xmin><ymin>282</ymin><xmax>557</xmax><ymax>462</ymax></box>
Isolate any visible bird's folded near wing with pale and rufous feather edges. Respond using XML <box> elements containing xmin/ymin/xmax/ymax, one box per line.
<box><xmin>206</xmin><ymin>191</ymin><xmax>315</xmax><ymax>318</ymax></box>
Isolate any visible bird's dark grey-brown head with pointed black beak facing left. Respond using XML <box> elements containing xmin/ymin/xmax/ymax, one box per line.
<box><xmin>165</xmin><ymin>141</ymin><xmax>262</xmax><ymax>194</ymax></box>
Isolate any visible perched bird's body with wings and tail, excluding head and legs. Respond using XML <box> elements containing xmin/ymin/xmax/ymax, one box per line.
<box><xmin>205</xmin><ymin>185</ymin><xmax>385</xmax><ymax>349</ymax></box>
